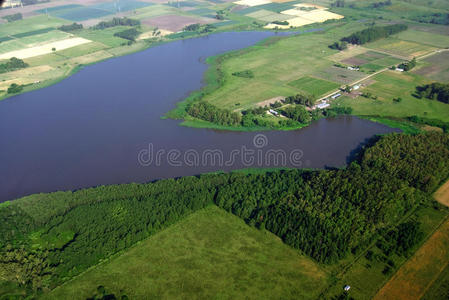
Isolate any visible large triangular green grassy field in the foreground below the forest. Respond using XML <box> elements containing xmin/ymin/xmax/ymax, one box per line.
<box><xmin>43</xmin><ymin>206</ymin><xmax>328</xmax><ymax>299</ymax></box>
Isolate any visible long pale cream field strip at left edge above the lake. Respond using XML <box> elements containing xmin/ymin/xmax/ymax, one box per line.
<box><xmin>0</xmin><ymin>37</ymin><xmax>91</xmax><ymax>59</ymax></box>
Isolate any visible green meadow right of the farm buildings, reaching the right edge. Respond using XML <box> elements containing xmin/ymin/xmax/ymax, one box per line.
<box><xmin>335</xmin><ymin>71</ymin><xmax>449</xmax><ymax>122</ymax></box>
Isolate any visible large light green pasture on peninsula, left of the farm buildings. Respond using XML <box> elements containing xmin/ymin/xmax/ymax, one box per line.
<box><xmin>205</xmin><ymin>24</ymin><xmax>372</xmax><ymax>110</ymax></box>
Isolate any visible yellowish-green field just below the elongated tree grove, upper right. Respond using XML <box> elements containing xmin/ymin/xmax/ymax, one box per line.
<box><xmin>365</xmin><ymin>38</ymin><xmax>436</xmax><ymax>59</ymax></box>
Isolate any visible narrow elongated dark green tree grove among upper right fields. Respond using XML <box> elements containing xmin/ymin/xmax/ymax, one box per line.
<box><xmin>341</xmin><ymin>24</ymin><xmax>408</xmax><ymax>45</ymax></box>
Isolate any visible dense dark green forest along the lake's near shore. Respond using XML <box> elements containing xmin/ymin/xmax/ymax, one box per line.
<box><xmin>0</xmin><ymin>132</ymin><xmax>449</xmax><ymax>294</ymax></box>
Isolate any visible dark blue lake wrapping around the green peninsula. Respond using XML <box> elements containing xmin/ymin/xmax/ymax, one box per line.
<box><xmin>0</xmin><ymin>32</ymin><xmax>400</xmax><ymax>201</ymax></box>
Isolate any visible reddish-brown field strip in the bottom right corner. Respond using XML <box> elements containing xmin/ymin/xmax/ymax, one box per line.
<box><xmin>374</xmin><ymin>216</ymin><xmax>449</xmax><ymax>300</ymax></box>
